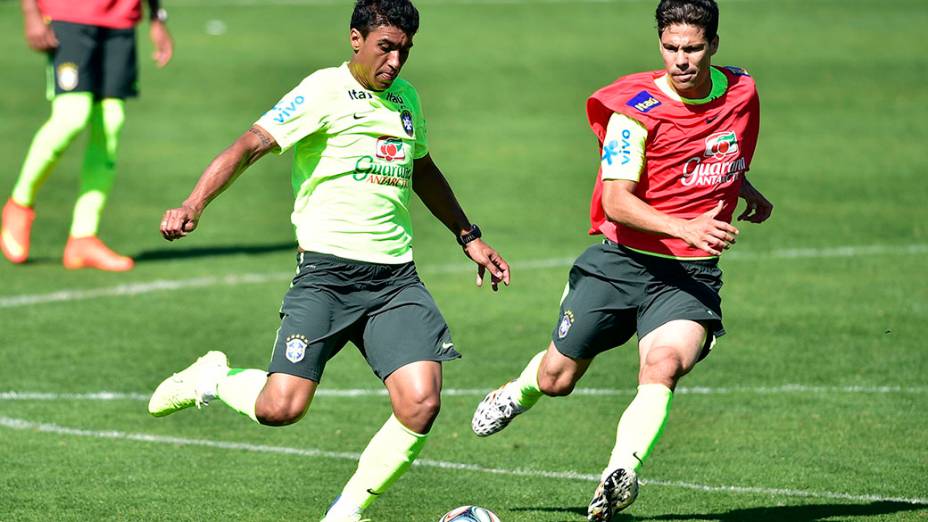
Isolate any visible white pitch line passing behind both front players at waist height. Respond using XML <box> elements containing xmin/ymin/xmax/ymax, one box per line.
<box><xmin>0</xmin><ymin>244</ymin><xmax>928</xmax><ymax>308</ymax></box>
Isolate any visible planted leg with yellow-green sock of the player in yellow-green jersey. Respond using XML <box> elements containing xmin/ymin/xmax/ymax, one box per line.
<box><xmin>323</xmin><ymin>361</ymin><xmax>441</xmax><ymax>522</ymax></box>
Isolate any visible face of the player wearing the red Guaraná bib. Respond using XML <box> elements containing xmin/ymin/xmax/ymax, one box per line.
<box><xmin>661</xmin><ymin>24</ymin><xmax>719</xmax><ymax>99</ymax></box>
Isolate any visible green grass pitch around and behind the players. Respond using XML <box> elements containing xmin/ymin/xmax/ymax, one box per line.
<box><xmin>0</xmin><ymin>0</ymin><xmax>928</xmax><ymax>522</ymax></box>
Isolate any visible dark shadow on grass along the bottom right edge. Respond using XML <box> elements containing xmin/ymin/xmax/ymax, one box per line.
<box><xmin>512</xmin><ymin>501</ymin><xmax>928</xmax><ymax>522</ymax></box>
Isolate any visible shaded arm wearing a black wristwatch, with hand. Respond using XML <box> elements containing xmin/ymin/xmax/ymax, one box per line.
<box><xmin>412</xmin><ymin>154</ymin><xmax>509</xmax><ymax>290</ymax></box>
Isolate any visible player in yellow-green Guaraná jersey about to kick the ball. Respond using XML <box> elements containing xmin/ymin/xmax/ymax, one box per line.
<box><xmin>149</xmin><ymin>0</ymin><xmax>509</xmax><ymax>522</ymax></box>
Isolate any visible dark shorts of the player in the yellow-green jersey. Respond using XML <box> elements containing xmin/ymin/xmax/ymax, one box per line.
<box><xmin>268</xmin><ymin>252</ymin><xmax>461</xmax><ymax>382</ymax></box>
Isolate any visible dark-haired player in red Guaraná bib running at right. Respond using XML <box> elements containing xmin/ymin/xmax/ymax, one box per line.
<box><xmin>473</xmin><ymin>0</ymin><xmax>773</xmax><ymax>521</ymax></box>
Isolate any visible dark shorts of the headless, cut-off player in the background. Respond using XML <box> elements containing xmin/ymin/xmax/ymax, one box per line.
<box><xmin>48</xmin><ymin>21</ymin><xmax>138</xmax><ymax>99</ymax></box>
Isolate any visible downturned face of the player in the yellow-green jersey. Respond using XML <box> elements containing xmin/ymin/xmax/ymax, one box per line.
<box><xmin>350</xmin><ymin>25</ymin><xmax>412</xmax><ymax>91</ymax></box>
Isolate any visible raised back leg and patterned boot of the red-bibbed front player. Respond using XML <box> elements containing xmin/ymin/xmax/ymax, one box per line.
<box><xmin>471</xmin><ymin>342</ymin><xmax>592</xmax><ymax>437</ymax></box>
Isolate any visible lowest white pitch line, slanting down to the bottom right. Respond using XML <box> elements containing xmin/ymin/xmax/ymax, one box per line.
<box><xmin>0</xmin><ymin>416</ymin><xmax>928</xmax><ymax>505</ymax></box>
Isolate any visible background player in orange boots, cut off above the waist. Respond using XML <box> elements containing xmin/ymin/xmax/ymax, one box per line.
<box><xmin>0</xmin><ymin>0</ymin><xmax>174</xmax><ymax>272</ymax></box>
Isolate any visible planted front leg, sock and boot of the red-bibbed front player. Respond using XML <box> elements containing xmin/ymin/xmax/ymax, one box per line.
<box><xmin>588</xmin><ymin>321</ymin><xmax>707</xmax><ymax>522</ymax></box>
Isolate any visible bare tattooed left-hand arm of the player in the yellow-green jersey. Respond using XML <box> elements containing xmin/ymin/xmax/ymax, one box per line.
<box><xmin>161</xmin><ymin>125</ymin><xmax>277</xmax><ymax>241</ymax></box>
